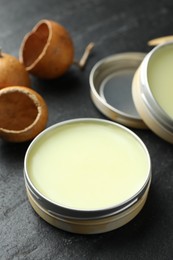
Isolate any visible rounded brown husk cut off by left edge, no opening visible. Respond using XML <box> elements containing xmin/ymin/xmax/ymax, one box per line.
<box><xmin>0</xmin><ymin>51</ymin><xmax>30</xmax><ymax>89</ymax></box>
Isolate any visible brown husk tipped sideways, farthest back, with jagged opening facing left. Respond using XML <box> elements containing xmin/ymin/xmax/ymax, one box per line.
<box><xmin>19</xmin><ymin>19</ymin><xmax>74</xmax><ymax>79</ymax></box>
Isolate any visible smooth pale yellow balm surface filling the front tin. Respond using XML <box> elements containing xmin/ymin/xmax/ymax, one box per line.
<box><xmin>26</xmin><ymin>121</ymin><xmax>150</xmax><ymax>210</ymax></box>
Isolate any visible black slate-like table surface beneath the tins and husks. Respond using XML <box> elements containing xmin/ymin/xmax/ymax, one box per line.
<box><xmin>0</xmin><ymin>0</ymin><xmax>173</xmax><ymax>260</ymax></box>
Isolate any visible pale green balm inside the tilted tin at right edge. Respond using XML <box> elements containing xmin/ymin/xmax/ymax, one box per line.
<box><xmin>147</xmin><ymin>44</ymin><xmax>173</xmax><ymax>118</ymax></box>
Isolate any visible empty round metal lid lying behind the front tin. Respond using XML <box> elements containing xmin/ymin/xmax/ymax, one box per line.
<box><xmin>89</xmin><ymin>52</ymin><xmax>146</xmax><ymax>128</ymax></box>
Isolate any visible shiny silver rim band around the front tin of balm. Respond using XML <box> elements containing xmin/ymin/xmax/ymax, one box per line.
<box><xmin>24</xmin><ymin>118</ymin><xmax>151</xmax><ymax>219</ymax></box>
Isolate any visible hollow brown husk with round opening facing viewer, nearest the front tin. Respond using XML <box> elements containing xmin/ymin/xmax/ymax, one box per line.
<box><xmin>0</xmin><ymin>86</ymin><xmax>48</xmax><ymax>142</ymax></box>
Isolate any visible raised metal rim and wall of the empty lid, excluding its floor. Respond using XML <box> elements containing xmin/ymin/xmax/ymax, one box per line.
<box><xmin>89</xmin><ymin>52</ymin><xmax>146</xmax><ymax>128</ymax></box>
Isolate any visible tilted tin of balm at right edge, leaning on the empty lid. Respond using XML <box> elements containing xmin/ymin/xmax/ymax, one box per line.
<box><xmin>132</xmin><ymin>42</ymin><xmax>173</xmax><ymax>143</ymax></box>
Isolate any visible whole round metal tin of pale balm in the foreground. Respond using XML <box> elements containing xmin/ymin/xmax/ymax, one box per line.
<box><xmin>24</xmin><ymin>118</ymin><xmax>151</xmax><ymax>234</ymax></box>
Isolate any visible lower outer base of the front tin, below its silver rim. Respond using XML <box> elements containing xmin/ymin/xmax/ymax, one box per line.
<box><xmin>26</xmin><ymin>186</ymin><xmax>150</xmax><ymax>234</ymax></box>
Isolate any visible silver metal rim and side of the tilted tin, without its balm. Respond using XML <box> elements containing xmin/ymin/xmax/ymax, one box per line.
<box><xmin>132</xmin><ymin>42</ymin><xmax>173</xmax><ymax>143</ymax></box>
